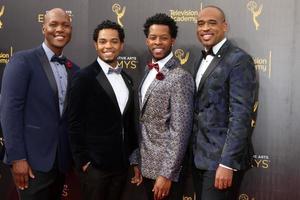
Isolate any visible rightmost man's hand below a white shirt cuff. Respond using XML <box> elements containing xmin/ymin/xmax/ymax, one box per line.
<box><xmin>215</xmin><ymin>166</ymin><xmax>233</xmax><ymax>190</ymax></box>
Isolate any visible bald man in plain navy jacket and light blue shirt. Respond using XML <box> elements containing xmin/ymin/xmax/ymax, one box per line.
<box><xmin>0</xmin><ymin>8</ymin><xmax>79</xmax><ymax>200</ymax></box>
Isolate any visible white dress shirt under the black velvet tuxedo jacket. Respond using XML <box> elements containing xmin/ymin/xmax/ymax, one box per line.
<box><xmin>97</xmin><ymin>57</ymin><xmax>129</xmax><ymax>114</ymax></box>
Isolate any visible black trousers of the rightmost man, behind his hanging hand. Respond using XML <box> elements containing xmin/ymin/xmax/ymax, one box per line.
<box><xmin>192</xmin><ymin>166</ymin><xmax>245</xmax><ymax>200</ymax></box>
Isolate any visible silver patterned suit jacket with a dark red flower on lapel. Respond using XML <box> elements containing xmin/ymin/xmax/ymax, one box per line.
<box><xmin>139</xmin><ymin>57</ymin><xmax>194</xmax><ymax>181</ymax></box>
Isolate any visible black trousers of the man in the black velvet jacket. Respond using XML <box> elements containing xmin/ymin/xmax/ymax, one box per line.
<box><xmin>79</xmin><ymin>165</ymin><xmax>128</xmax><ymax>200</ymax></box>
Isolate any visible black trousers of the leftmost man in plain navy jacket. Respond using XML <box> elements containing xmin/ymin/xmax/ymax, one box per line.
<box><xmin>18</xmin><ymin>169</ymin><xmax>65</xmax><ymax>200</ymax></box>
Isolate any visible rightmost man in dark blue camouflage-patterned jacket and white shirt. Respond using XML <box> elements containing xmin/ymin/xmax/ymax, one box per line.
<box><xmin>192</xmin><ymin>6</ymin><xmax>257</xmax><ymax>200</ymax></box>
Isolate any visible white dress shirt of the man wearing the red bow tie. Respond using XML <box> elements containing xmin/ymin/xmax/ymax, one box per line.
<box><xmin>141</xmin><ymin>52</ymin><xmax>173</xmax><ymax>102</ymax></box>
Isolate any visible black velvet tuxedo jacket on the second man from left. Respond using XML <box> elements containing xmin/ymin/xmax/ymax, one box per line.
<box><xmin>68</xmin><ymin>61</ymin><xmax>137</xmax><ymax>171</ymax></box>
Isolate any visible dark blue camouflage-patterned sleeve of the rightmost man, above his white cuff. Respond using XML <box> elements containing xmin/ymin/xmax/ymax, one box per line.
<box><xmin>220</xmin><ymin>54</ymin><xmax>257</xmax><ymax>170</ymax></box>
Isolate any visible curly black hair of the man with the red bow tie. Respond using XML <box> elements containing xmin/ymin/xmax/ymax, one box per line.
<box><xmin>144</xmin><ymin>13</ymin><xmax>178</xmax><ymax>39</ymax></box>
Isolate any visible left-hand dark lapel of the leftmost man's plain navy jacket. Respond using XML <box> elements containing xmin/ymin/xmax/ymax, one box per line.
<box><xmin>37</xmin><ymin>46</ymin><xmax>58</xmax><ymax>106</ymax></box>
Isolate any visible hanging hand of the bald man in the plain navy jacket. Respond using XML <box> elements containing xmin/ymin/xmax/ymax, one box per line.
<box><xmin>12</xmin><ymin>160</ymin><xmax>34</xmax><ymax>190</ymax></box>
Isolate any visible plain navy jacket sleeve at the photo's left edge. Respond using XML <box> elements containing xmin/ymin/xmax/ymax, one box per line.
<box><xmin>0</xmin><ymin>53</ymin><xmax>31</xmax><ymax>164</ymax></box>
